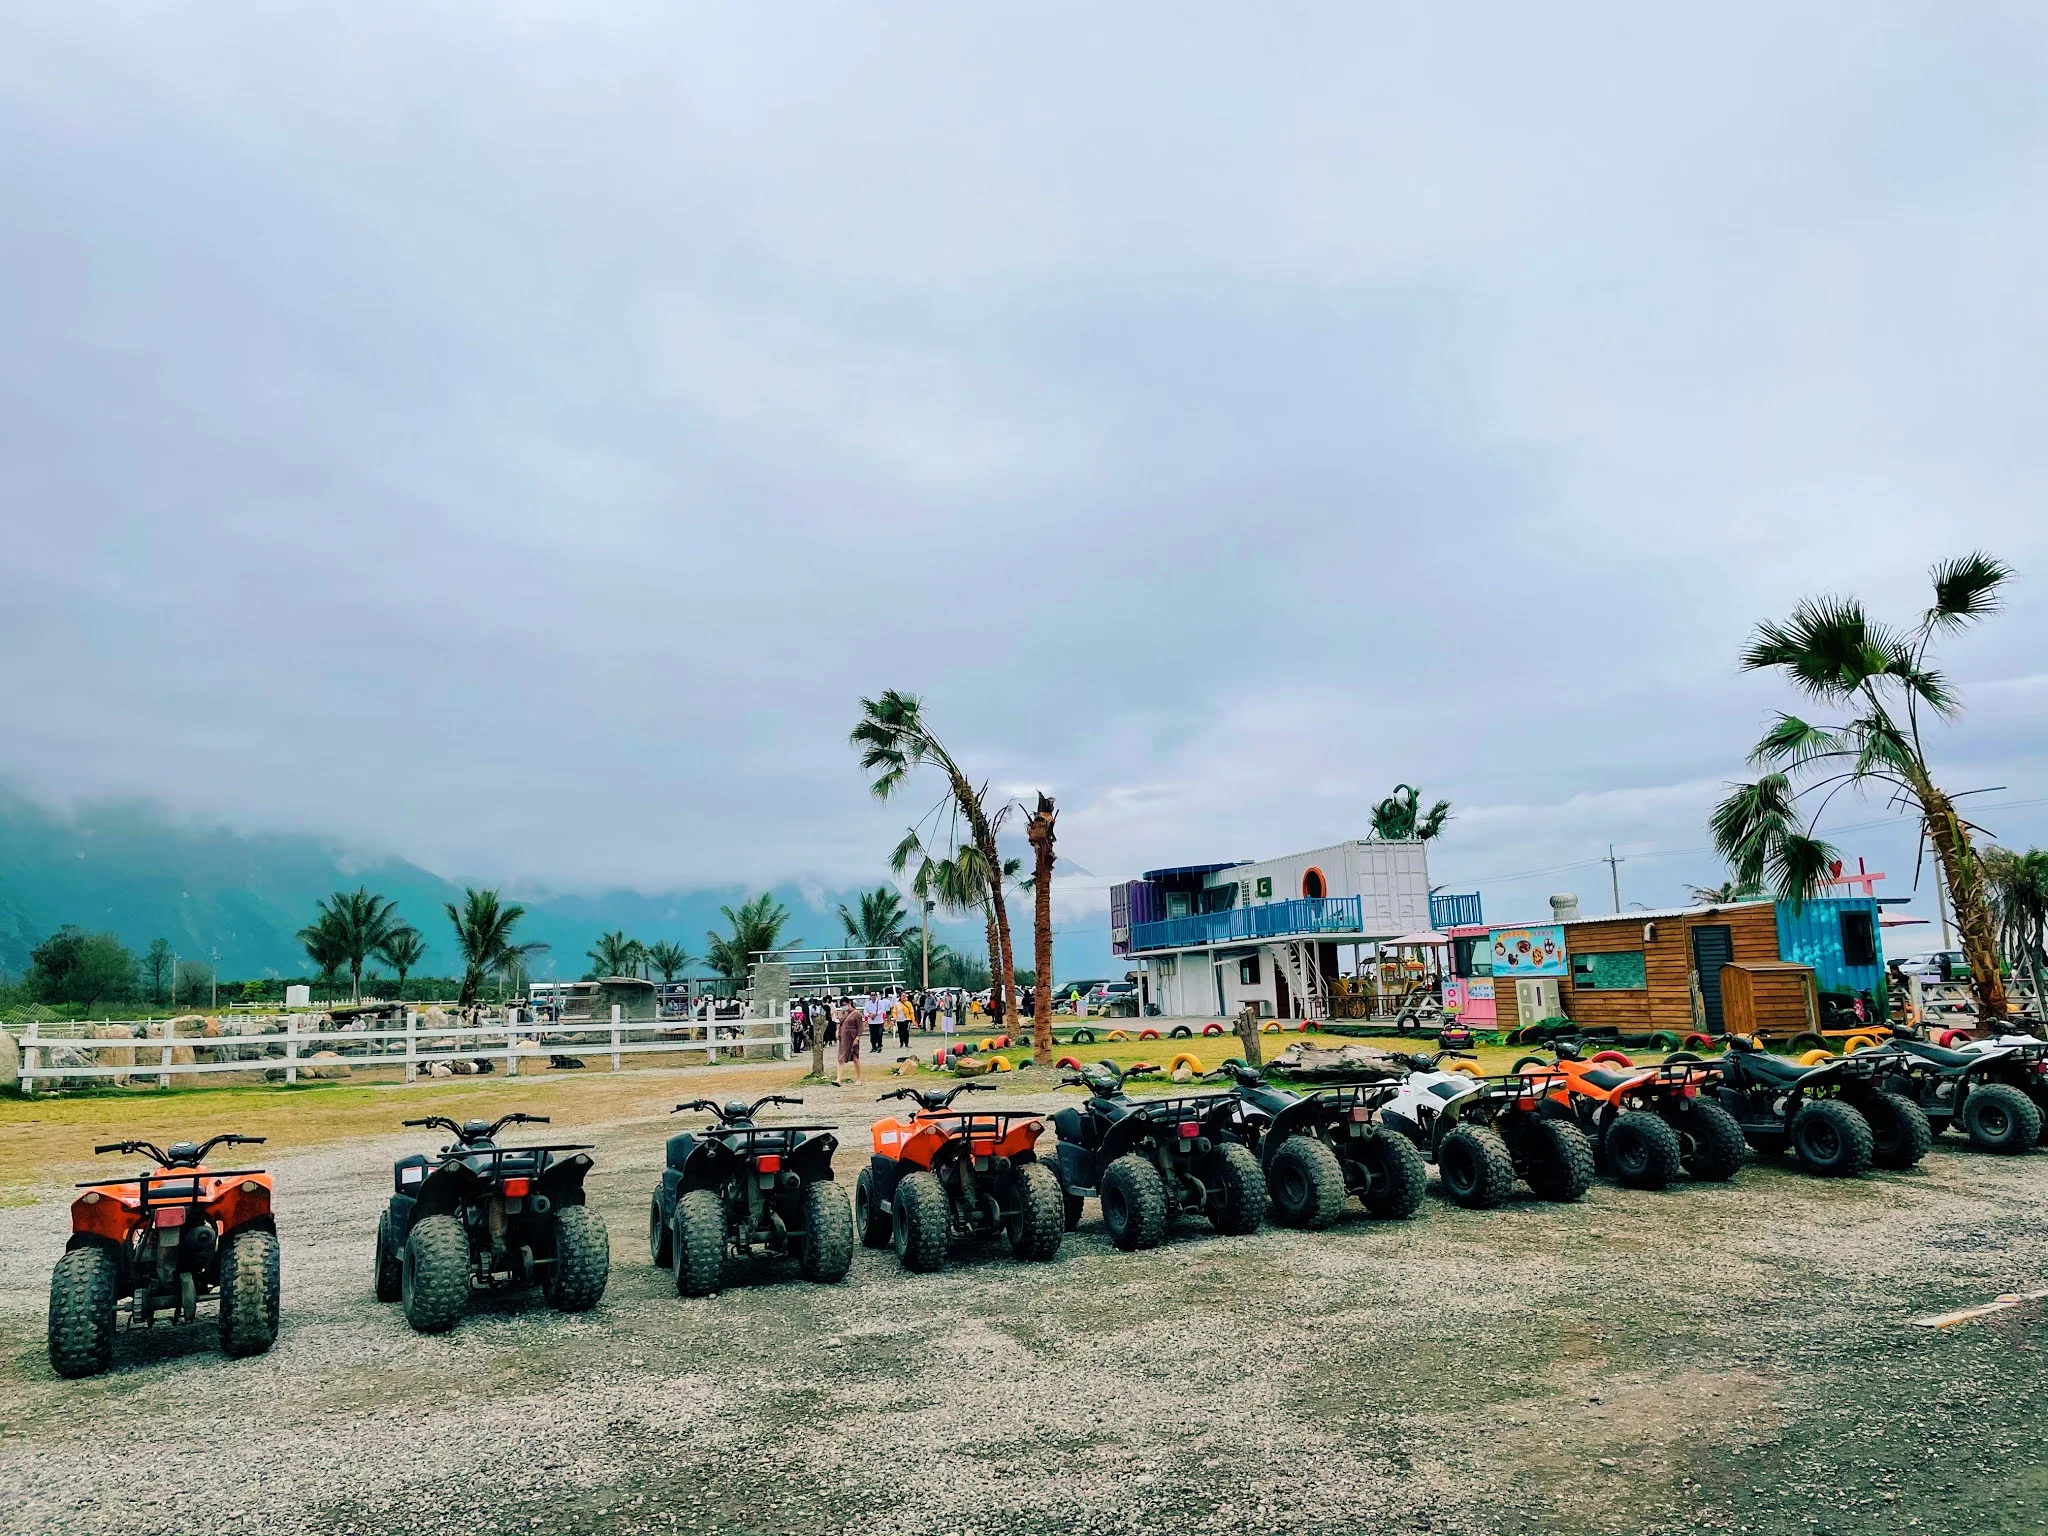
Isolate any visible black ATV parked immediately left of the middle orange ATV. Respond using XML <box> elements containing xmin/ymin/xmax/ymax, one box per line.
<box><xmin>647</xmin><ymin>1094</ymin><xmax>854</xmax><ymax>1296</ymax></box>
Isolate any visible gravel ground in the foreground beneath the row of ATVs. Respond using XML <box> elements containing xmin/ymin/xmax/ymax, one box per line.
<box><xmin>0</xmin><ymin>1073</ymin><xmax>2048</xmax><ymax>1536</ymax></box>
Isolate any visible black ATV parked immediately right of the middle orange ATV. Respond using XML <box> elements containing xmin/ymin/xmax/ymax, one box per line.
<box><xmin>1053</xmin><ymin>1061</ymin><xmax>1266</xmax><ymax>1251</ymax></box>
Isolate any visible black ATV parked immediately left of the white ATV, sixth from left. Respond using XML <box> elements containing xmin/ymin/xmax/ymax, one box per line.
<box><xmin>1210</xmin><ymin>1061</ymin><xmax>1430</xmax><ymax>1231</ymax></box>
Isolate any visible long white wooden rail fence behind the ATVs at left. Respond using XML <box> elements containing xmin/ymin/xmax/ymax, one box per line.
<box><xmin>20</xmin><ymin>1004</ymin><xmax>791</xmax><ymax>1094</ymax></box>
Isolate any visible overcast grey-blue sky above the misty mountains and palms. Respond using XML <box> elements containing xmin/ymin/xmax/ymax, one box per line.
<box><xmin>0</xmin><ymin>0</ymin><xmax>2048</xmax><ymax>948</ymax></box>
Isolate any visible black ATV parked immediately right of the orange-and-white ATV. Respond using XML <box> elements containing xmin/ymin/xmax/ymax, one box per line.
<box><xmin>1718</xmin><ymin>1036</ymin><xmax>1933</xmax><ymax>1178</ymax></box>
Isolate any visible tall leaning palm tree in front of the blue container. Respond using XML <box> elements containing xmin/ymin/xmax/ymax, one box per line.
<box><xmin>1710</xmin><ymin>551</ymin><xmax>2011</xmax><ymax>1022</ymax></box>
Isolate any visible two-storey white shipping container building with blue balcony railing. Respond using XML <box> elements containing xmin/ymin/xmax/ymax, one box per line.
<box><xmin>1110</xmin><ymin>840</ymin><xmax>1430</xmax><ymax>1018</ymax></box>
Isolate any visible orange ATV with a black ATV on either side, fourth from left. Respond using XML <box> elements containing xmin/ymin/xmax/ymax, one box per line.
<box><xmin>854</xmin><ymin>1083</ymin><xmax>1067</xmax><ymax>1272</ymax></box>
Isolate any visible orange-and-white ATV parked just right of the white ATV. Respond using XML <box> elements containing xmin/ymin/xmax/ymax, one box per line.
<box><xmin>1516</xmin><ymin>1038</ymin><xmax>1743</xmax><ymax>1190</ymax></box>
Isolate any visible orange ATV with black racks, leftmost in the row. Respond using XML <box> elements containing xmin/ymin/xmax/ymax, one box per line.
<box><xmin>49</xmin><ymin>1135</ymin><xmax>279</xmax><ymax>1376</ymax></box>
